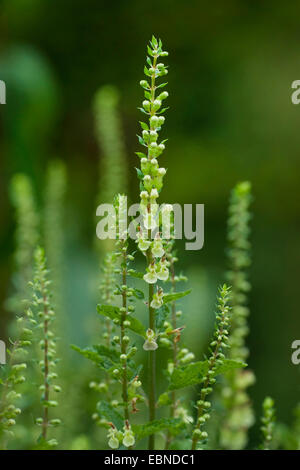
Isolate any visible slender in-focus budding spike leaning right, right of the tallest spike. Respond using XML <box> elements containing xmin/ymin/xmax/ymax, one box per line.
<box><xmin>192</xmin><ymin>284</ymin><xmax>230</xmax><ymax>450</ymax></box>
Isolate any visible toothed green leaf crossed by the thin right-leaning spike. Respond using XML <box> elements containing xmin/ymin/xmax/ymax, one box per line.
<box><xmin>168</xmin><ymin>359</ymin><xmax>246</xmax><ymax>390</ymax></box>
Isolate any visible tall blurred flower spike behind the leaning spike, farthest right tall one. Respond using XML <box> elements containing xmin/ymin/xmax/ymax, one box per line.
<box><xmin>220</xmin><ymin>181</ymin><xmax>255</xmax><ymax>449</ymax></box>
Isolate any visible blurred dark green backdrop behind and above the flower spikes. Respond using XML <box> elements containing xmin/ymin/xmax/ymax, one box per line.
<box><xmin>0</xmin><ymin>0</ymin><xmax>300</xmax><ymax>440</ymax></box>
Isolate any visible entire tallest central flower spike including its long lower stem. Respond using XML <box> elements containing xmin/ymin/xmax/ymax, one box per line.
<box><xmin>137</xmin><ymin>36</ymin><xmax>169</xmax><ymax>449</ymax></box>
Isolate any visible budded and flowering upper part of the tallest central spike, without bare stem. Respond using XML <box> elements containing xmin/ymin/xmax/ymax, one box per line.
<box><xmin>137</xmin><ymin>37</ymin><xmax>169</xmax><ymax>284</ymax></box>
